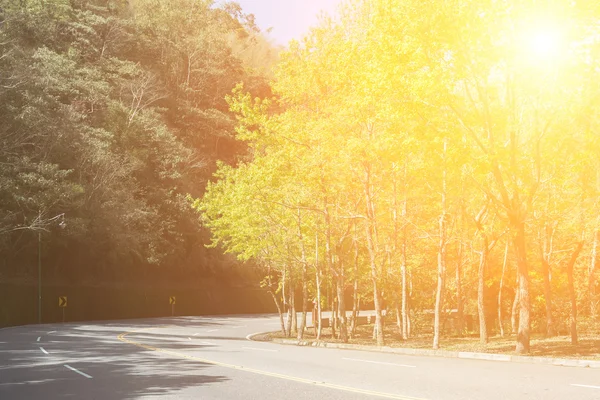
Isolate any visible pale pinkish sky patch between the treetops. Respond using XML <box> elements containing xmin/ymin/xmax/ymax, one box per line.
<box><xmin>227</xmin><ymin>0</ymin><xmax>341</xmax><ymax>45</ymax></box>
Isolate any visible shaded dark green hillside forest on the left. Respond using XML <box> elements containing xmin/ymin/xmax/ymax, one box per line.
<box><xmin>0</xmin><ymin>0</ymin><xmax>279</xmax><ymax>288</ymax></box>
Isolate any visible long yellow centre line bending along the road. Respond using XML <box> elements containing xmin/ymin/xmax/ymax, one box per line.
<box><xmin>117</xmin><ymin>328</ymin><xmax>425</xmax><ymax>400</ymax></box>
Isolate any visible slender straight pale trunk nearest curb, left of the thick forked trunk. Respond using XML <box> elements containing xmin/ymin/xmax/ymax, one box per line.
<box><xmin>433</xmin><ymin>139</ymin><xmax>448</xmax><ymax>349</ymax></box>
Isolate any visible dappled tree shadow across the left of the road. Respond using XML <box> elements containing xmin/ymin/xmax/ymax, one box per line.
<box><xmin>0</xmin><ymin>318</ymin><xmax>251</xmax><ymax>400</ymax></box>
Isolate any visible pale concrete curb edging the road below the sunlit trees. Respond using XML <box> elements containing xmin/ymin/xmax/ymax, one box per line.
<box><xmin>258</xmin><ymin>332</ymin><xmax>600</xmax><ymax>369</ymax></box>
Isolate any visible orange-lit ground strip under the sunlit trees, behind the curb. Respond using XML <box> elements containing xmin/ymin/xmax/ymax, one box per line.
<box><xmin>262</xmin><ymin>325</ymin><xmax>600</xmax><ymax>359</ymax></box>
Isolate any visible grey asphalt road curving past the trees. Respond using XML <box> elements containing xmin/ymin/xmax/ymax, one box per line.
<box><xmin>0</xmin><ymin>315</ymin><xmax>600</xmax><ymax>400</ymax></box>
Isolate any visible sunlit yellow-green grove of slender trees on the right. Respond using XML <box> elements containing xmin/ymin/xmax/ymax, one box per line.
<box><xmin>199</xmin><ymin>0</ymin><xmax>600</xmax><ymax>353</ymax></box>
